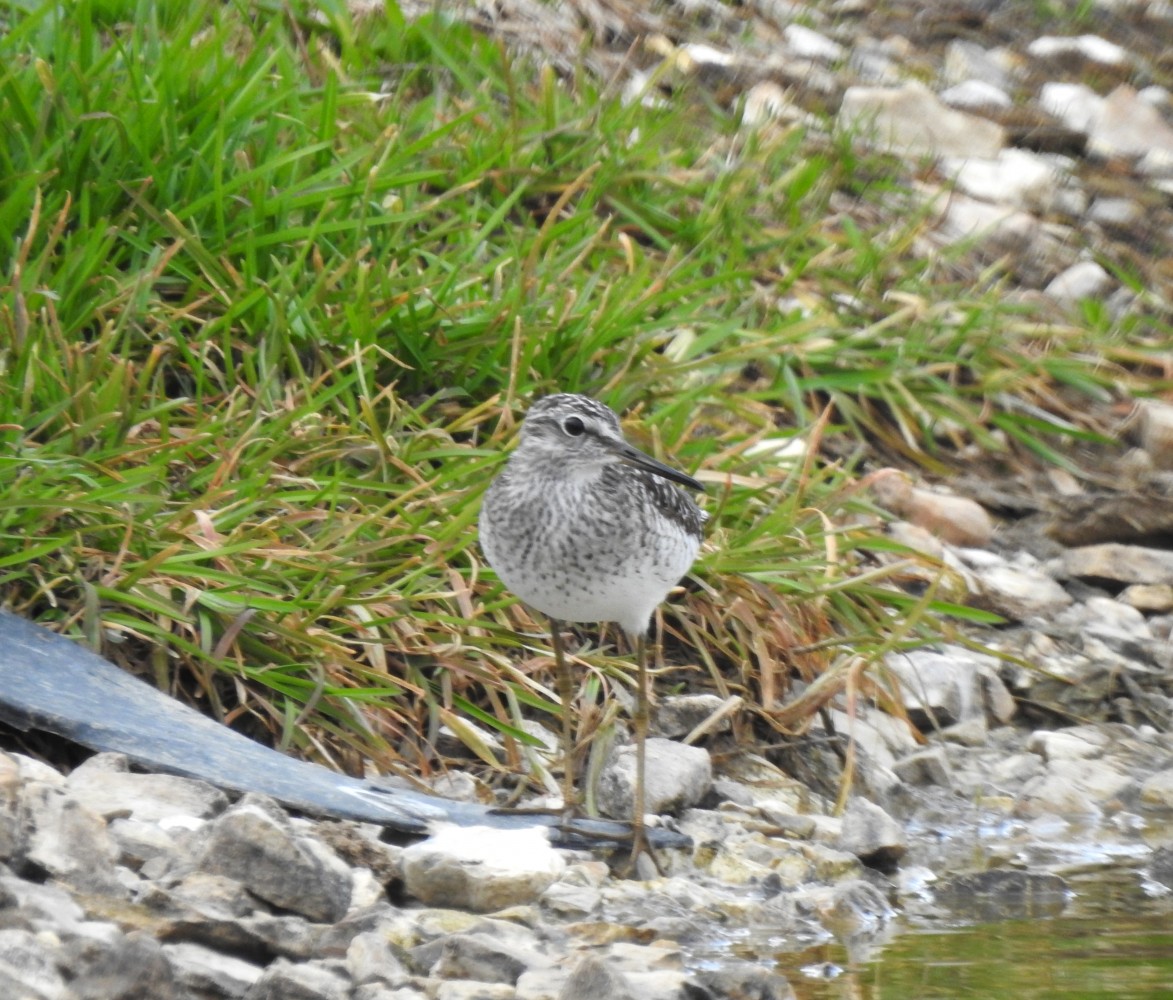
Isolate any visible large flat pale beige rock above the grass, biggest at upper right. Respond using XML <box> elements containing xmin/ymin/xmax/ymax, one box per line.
<box><xmin>839</xmin><ymin>83</ymin><xmax>1005</xmax><ymax>158</ymax></box>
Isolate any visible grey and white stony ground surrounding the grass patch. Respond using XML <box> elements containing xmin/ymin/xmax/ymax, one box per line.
<box><xmin>0</xmin><ymin>0</ymin><xmax>1173</xmax><ymax>1000</ymax></box>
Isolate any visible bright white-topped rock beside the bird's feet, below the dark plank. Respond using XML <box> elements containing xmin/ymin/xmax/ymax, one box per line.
<box><xmin>404</xmin><ymin>825</ymin><xmax>567</xmax><ymax>913</ymax></box>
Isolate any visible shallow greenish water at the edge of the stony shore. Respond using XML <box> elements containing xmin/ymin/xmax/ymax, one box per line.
<box><xmin>689</xmin><ymin>868</ymin><xmax>1173</xmax><ymax>1000</ymax></box>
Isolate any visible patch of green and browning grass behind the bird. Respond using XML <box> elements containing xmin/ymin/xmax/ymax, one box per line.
<box><xmin>0</xmin><ymin>2</ymin><xmax>1168</xmax><ymax>787</ymax></box>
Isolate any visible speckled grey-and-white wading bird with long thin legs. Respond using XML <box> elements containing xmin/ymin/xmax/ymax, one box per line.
<box><xmin>479</xmin><ymin>393</ymin><xmax>708</xmax><ymax>868</ymax></box>
